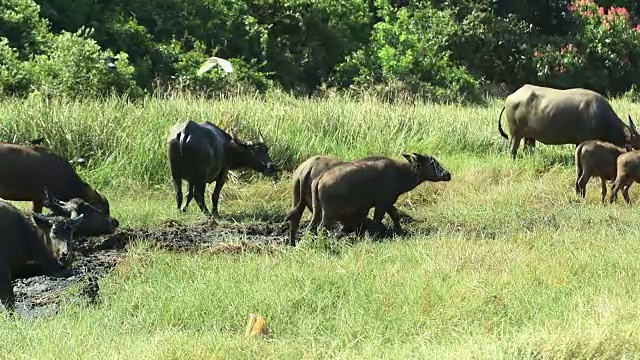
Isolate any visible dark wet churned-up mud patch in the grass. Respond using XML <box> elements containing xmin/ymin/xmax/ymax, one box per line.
<box><xmin>13</xmin><ymin>221</ymin><xmax>288</xmax><ymax>317</ymax></box>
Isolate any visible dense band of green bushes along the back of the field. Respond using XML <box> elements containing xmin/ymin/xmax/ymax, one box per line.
<box><xmin>0</xmin><ymin>0</ymin><xmax>640</xmax><ymax>100</ymax></box>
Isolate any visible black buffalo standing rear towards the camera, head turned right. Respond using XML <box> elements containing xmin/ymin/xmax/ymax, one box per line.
<box><xmin>167</xmin><ymin>120</ymin><xmax>277</xmax><ymax>215</ymax></box>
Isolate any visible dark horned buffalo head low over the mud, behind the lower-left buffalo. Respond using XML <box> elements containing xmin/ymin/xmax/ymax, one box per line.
<box><xmin>44</xmin><ymin>191</ymin><xmax>120</xmax><ymax>237</ymax></box>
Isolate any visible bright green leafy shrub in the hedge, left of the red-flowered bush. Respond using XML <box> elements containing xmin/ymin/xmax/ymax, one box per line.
<box><xmin>340</xmin><ymin>5</ymin><xmax>478</xmax><ymax>100</ymax></box>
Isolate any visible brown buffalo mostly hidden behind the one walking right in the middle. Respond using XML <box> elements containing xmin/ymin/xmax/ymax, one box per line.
<box><xmin>284</xmin><ymin>155</ymin><xmax>376</xmax><ymax>246</ymax></box>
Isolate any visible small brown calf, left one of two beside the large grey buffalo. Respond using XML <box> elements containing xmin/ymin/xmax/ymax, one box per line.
<box><xmin>575</xmin><ymin>140</ymin><xmax>627</xmax><ymax>203</ymax></box>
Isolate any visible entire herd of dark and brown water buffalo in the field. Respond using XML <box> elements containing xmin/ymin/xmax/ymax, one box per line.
<box><xmin>0</xmin><ymin>84</ymin><xmax>640</xmax><ymax>309</ymax></box>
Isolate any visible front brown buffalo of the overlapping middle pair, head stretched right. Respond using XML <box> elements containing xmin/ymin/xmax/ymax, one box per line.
<box><xmin>307</xmin><ymin>153</ymin><xmax>451</xmax><ymax>238</ymax></box>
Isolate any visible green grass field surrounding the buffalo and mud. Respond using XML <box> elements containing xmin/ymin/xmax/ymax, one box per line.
<box><xmin>0</xmin><ymin>94</ymin><xmax>640</xmax><ymax>359</ymax></box>
